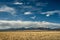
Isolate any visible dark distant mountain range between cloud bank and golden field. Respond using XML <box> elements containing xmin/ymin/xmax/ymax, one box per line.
<box><xmin>0</xmin><ymin>27</ymin><xmax>60</xmax><ymax>31</ymax></box>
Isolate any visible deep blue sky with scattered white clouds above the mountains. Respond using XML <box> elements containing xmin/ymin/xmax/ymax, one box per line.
<box><xmin>0</xmin><ymin>0</ymin><xmax>60</xmax><ymax>29</ymax></box>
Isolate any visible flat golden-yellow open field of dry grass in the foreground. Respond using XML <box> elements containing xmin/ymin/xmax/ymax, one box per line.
<box><xmin>0</xmin><ymin>31</ymin><xmax>60</xmax><ymax>40</ymax></box>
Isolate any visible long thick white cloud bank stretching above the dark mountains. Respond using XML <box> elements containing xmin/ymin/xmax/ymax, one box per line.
<box><xmin>0</xmin><ymin>20</ymin><xmax>60</xmax><ymax>29</ymax></box>
